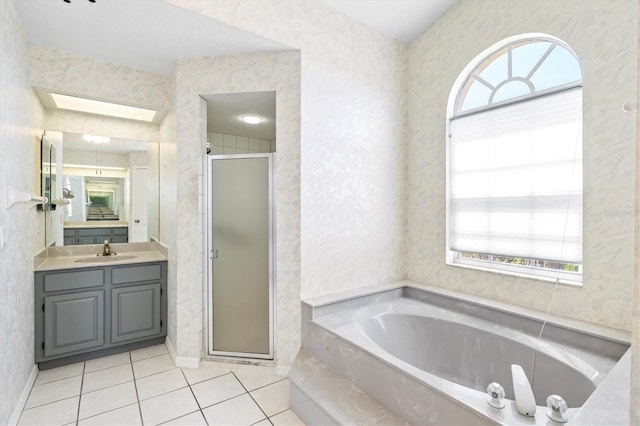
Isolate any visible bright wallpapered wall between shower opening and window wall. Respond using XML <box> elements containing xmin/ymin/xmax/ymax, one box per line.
<box><xmin>169</xmin><ymin>0</ymin><xmax>406</xmax><ymax>298</ymax></box>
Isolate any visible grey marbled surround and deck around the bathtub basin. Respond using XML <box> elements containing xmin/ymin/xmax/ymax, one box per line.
<box><xmin>300</xmin><ymin>280</ymin><xmax>630</xmax><ymax>424</ymax></box>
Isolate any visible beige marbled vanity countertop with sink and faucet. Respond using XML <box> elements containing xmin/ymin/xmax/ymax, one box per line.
<box><xmin>34</xmin><ymin>242</ymin><xmax>168</xmax><ymax>271</ymax></box>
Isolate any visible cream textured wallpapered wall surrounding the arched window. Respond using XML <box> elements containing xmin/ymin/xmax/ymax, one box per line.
<box><xmin>407</xmin><ymin>0</ymin><xmax>638</xmax><ymax>330</ymax></box>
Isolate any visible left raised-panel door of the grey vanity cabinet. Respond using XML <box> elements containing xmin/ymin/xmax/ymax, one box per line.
<box><xmin>44</xmin><ymin>290</ymin><xmax>104</xmax><ymax>356</ymax></box>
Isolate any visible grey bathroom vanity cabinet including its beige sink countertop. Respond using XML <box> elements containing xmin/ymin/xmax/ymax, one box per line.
<box><xmin>34</xmin><ymin>244</ymin><xmax>167</xmax><ymax>370</ymax></box>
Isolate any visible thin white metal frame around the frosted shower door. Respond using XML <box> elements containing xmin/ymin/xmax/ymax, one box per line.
<box><xmin>205</xmin><ymin>153</ymin><xmax>276</xmax><ymax>360</ymax></box>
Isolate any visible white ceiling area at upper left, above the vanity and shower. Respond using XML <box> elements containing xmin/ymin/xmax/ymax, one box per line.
<box><xmin>15</xmin><ymin>0</ymin><xmax>290</xmax><ymax>75</ymax></box>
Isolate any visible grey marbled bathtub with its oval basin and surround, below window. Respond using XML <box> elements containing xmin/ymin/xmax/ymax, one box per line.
<box><xmin>303</xmin><ymin>287</ymin><xmax>629</xmax><ymax>425</ymax></box>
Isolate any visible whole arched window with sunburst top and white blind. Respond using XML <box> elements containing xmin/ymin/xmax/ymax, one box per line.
<box><xmin>447</xmin><ymin>35</ymin><xmax>582</xmax><ymax>282</ymax></box>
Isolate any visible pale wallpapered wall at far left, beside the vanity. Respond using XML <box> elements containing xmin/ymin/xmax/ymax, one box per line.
<box><xmin>0</xmin><ymin>1</ymin><xmax>44</xmax><ymax>425</ymax></box>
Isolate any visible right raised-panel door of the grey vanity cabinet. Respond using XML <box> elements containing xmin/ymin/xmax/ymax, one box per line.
<box><xmin>111</xmin><ymin>283</ymin><xmax>161</xmax><ymax>343</ymax></box>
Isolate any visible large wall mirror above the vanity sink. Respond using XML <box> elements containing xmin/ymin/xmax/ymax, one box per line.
<box><xmin>45</xmin><ymin>132</ymin><xmax>159</xmax><ymax>245</ymax></box>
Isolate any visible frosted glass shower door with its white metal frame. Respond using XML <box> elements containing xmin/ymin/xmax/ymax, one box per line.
<box><xmin>207</xmin><ymin>154</ymin><xmax>274</xmax><ymax>359</ymax></box>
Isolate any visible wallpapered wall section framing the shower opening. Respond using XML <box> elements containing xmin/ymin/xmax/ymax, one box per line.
<box><xmin>168</xmin><ymin>52</ymin><xmax>300</xmax><ymax>366</ymax></box>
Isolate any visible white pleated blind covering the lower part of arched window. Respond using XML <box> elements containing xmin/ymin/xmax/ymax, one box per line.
<box><xmin>449</xmin><ymin>87</ymin><xmax>582</xmax><ymax>263</ymax></box>
